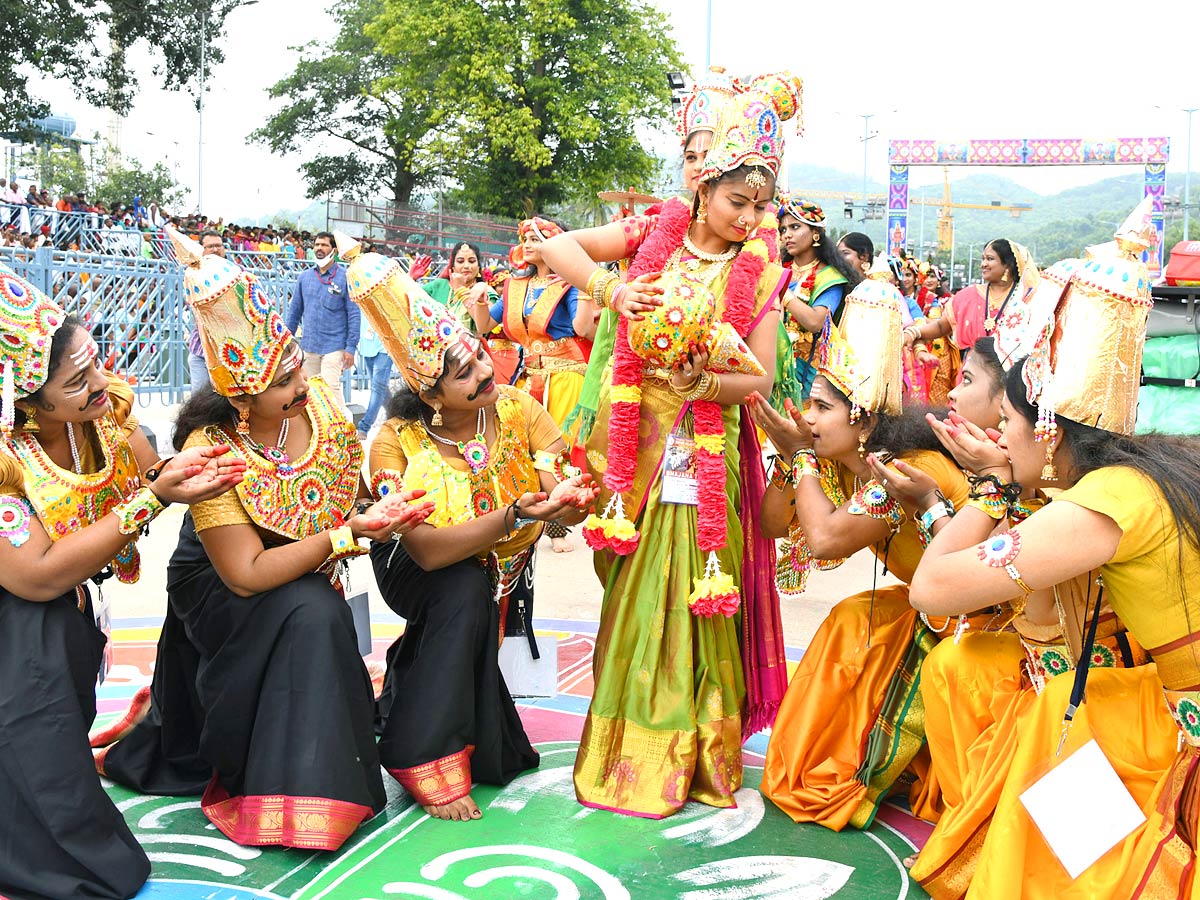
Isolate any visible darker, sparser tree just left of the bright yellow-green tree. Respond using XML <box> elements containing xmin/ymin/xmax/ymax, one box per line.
<box><xmin>250</xmin><ymin>0</ymin><xmax>445</xmax><ymax>203</ymax></box>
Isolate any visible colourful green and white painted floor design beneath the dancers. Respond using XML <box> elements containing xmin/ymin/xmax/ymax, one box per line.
<box><xmin>100</xmin><ymin>620</ymin><xmax>929</xmax><ymax>900</ymax></box>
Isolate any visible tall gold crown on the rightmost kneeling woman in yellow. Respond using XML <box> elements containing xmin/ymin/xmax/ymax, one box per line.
<box><xmin>1021</xmin><ymin>197</ymin><xmax>1156</xmax><ymax>434</ymax></box>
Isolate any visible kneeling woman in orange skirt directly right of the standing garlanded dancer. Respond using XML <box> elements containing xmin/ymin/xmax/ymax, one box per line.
<box><xmin>752</xmin><ymin>280</ymin><xmax>967</xmax><ymax>832</ymax></box>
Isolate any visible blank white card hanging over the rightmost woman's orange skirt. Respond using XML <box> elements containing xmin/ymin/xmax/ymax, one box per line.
<box><xmin>1021</xmin><ymin>740</ymin><xmax>1146</xmax><ymax>878</ymax></box>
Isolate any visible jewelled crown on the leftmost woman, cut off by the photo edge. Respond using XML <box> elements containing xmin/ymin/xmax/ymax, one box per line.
<box><xmin>0</xmin><ymin>265</ymin><xmax>66</xmax><ymax>438</ymax></box>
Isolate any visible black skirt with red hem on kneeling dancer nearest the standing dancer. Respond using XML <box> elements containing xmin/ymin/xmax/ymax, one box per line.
<box><xmin>371</xmin><ymin>542</ymin><xmax>539</xmax><ymax>803</ymax></box>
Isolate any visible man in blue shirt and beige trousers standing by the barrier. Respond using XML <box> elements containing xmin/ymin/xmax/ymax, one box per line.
<box><xmin>284</xmin><ymin>232</ymin><xmax>361</xmax><ymax>407</ymax></box>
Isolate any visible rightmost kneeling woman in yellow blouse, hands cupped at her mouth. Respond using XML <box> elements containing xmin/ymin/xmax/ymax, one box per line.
<box><xmin>912</xmin><ymin>210</ymin><xmax>1200</xmax><ymax>900</ymax></box>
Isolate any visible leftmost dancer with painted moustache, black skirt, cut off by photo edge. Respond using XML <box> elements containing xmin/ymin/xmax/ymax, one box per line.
<box><xmin>0</xmin><ymin>269</ymin><xmax>242</xmax><ymax>900</ymax></box>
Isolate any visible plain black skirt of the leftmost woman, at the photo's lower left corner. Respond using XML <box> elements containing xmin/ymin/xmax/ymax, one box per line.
<box><xmin>0</xmin><ymin>590</ymin><xmax>150</xmax><ymax>900</ymax></box>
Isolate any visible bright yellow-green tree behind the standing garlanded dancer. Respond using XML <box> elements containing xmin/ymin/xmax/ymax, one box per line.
<box><xmin>366</xmin><ymin>0</ymin><xmax>683</xmax><ymax>216</ymax></box>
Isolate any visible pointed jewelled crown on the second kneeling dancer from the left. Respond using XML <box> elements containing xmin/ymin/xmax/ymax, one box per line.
<box><xmin>166</xmin><ymin>226</ymin><xmax>294</xmax><ymax>397</ymax></box>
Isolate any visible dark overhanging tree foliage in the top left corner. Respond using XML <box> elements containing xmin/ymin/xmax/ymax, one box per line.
<box><xmin>0</xmin><ymin>0</ymin><xmax>245</xmax><ymax>131</ymax></box>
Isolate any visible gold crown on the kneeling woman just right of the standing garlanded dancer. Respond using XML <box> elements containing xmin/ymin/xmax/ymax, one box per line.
<box><xmin>817</xmin><ymin>254</ymin><xmax>904</xmax><ymax>421</ymax></box>
